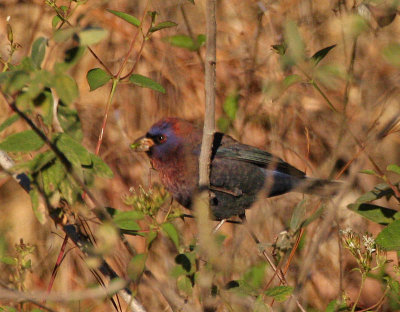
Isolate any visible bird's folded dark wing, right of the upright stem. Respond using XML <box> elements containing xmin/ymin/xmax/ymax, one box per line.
<box><xmin>213</xmin><ymin>133</ymin><xmax>305</xmax><ymax>178</ymax></box>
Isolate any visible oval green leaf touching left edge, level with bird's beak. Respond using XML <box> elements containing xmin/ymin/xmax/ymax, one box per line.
<box><xmin>0</xmin><ymin>130</ymin><xmax>44</xmax><ymax>152</ymax></box>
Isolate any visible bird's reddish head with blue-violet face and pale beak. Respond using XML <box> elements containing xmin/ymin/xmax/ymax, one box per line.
<box><xmin>131</xmin><ymin>117</ymin><xmax>198</xmax><ymax>161</ymax></box>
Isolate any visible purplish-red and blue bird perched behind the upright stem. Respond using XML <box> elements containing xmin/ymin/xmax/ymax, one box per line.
<box><xmin>131</xmin><ymin>117</ymin><xmax>340</xmax><ymax>220</ymax></box>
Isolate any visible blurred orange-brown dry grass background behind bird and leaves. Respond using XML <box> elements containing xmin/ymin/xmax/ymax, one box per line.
<box><xmin>0</xmin><ymin>0</ymin><xmax>400</xmax><ymax>311</ymax></box>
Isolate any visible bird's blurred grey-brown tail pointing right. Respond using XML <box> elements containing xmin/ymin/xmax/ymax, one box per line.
<box><xmin>294</xmin><ymin>177</ymin><xmax>343</xmax><ymax>196</ymax></box>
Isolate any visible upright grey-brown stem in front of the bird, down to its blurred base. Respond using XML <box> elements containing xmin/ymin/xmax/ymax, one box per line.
<box><xmin>199</xmin><ymin>0</ymin><xmax>217</xmax><ymax>187</ymax></box>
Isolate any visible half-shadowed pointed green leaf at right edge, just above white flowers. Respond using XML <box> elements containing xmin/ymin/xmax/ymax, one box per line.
<box><xmin>347</xmin><ymin>203</ymin><xmax>400</xmax><ymax>225</ymax></box>
